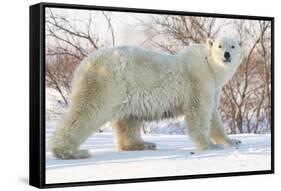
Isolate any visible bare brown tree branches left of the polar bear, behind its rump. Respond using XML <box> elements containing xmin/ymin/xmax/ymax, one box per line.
<box><xmin>46</xmin><ymin>9</ymin><xmax>115</xmax><ymax>105</ymax></box>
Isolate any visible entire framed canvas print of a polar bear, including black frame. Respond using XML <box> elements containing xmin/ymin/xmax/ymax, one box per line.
<box><xmin>29</xmin><ymin>3</ymin><xmax>274</xmax><ymax>188</ymax></box>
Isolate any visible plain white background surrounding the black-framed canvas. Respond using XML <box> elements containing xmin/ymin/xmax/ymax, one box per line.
<box><xmin>0</xmin><ymin>0</ymin><xmax>281</xmax><ymax>191</ymax></box>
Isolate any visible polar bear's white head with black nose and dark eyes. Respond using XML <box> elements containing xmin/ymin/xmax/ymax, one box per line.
<box><xmin>207</xmin><ymin>37</ymin><xmax>243</xmax><ymax>68</ymax></box>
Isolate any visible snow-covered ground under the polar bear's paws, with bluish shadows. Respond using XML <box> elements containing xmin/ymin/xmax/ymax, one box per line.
<box><xmin>46</xmin><ymin>124</ymin><xmax>271</xmax><ymax>184</ymax></box>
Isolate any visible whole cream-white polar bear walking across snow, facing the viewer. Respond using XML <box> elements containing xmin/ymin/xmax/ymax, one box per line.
<box><xmin>49</xmin><ymin>37</ymin><xmax>243</xmax><ymax>159</ymax></box>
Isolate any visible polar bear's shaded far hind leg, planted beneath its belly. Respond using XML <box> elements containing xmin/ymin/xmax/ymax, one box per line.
<box><xmin>113</xmin><ymin>117</ymin><xmax>156</xmax><ymax>151</ymax></box>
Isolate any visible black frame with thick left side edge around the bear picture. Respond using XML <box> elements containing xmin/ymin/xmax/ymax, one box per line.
<box><xmin>29</xmin><ymin>3</ymin><xmax>275</xmax><ymax>188</ymax></box>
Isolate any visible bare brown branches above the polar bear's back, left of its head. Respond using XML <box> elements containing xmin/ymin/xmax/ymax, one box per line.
<box><xmin>140</xmin><ymin>15</ymin><xmax>222</xmax><ymax>54</ymax></box>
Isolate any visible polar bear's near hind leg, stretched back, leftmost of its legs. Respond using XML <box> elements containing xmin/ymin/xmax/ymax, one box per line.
<box><xmin>49</xmin><ymin>74</ymin><xmax>108</xmax><ymax>159</ymax></box>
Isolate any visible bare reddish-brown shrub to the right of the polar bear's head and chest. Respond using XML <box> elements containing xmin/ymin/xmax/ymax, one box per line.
<box><xmin>221</xmin><ymin>20</ymin><xmax>271</xmax><ymax>133</ymax></box>
